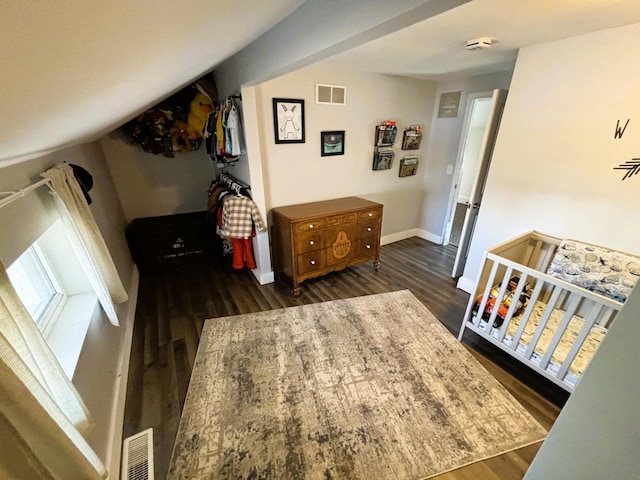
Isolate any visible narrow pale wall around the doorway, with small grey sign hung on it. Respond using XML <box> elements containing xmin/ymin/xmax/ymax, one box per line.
<box><xmin>420</xmin><ymin>72</ymin><xmax>511</xmax><ymax>242</ymax></box>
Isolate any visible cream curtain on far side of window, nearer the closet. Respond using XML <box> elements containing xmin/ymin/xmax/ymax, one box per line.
<box><xmin>41</xmin><ymin>163</ymin><xmax>129</xmax><ymax>325</ymax></box>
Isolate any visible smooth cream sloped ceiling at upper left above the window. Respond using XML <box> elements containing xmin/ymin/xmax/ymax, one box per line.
<box><xmin>0</xmin><ymin>0</ymin><xmax>304</xmax><ymax>166</ymax></box>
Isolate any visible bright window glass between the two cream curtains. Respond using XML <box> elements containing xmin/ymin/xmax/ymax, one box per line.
<box><xmin>7</xmin><ymin>241</ymin><xmax>66</xmax><ymax>334</ymax></box>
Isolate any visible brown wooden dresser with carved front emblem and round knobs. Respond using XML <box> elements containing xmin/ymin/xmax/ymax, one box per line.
<box><xmin>271</xmin><ymin>197</ymin><xmax>382</xmax><ymax>295</ymax></box>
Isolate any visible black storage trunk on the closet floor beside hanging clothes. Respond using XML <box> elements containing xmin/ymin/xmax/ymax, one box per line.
<box><xmin>126</xmin><ymin>212</ymin><xmax>216</xmax><ymax>272</ymax></box>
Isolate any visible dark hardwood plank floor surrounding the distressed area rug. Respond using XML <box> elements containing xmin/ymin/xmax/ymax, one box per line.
<box><xmin>124</xmin><ymin>237</ymin><xmax>568</xmax><ymax>480</ymax></box>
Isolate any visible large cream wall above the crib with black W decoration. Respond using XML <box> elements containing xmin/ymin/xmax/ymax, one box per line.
<box><xmin>464</xmin><ymin>24</ymin><xmax>640</xmax><ymax>292</ymax></box>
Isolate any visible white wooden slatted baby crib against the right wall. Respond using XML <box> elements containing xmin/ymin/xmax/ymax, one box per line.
<box><xmin>458</xmin><ymin>231</ymin><xmax>636</xmax><ymax>392</ymax></box>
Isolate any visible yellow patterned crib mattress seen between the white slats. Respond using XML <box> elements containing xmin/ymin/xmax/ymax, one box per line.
<box><xmin>480</xmin><ymin>301</ymin><xmax>607</xmax><ymax>385</ymax></box>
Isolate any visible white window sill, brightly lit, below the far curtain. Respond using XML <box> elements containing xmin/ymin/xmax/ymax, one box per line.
<box><xmin>46</xmin><ymin>292</ymin><xmax>98</xmax><ymax>380</ymax></box>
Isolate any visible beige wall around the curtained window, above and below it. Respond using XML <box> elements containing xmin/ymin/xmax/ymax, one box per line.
<box><xmin>0</xmin><ymin>143</ymin><xmax>136</xmax><ymax>468</ymax></box>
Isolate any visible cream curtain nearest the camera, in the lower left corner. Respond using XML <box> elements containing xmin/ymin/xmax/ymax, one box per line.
<box><xmin>0</xmin><ymin>262</ymin><xmax>107</xmax><ymax>480</ymax></box>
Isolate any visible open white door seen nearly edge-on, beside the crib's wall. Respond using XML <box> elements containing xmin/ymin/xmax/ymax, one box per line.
<box><xmin>451</xmin><ymin>90</ymin><xmax>507</xmax><ymax>277</ymax></box>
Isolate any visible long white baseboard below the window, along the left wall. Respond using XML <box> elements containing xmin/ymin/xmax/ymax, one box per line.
<box><xmin>105</xmin><ymin>265</ymin><xmax>140</xmax><ymax>480</ymax></box>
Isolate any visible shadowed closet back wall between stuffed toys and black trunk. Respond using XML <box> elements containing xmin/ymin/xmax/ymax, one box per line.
<box><xmin>100</xmin><ymin>131</ymin><xmax>217</xmax><ymax>222</ymax></box>
